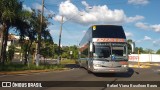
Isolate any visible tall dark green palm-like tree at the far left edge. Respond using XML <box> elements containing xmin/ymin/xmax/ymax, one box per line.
<box><xmin>0</xmin><ymin>0</ymin><xmax>23</xmax><ymax>64</ymax></box>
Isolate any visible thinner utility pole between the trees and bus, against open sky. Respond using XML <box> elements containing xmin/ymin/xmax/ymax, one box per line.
<box><xmin>58</xmin><ymin>16</ymin><xmax>63</xmax><ymax>64</ymax></box>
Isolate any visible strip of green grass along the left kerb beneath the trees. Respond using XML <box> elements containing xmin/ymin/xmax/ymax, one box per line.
<box><xmin>0</xmin><ymin>59</ymin><xmax>76</xmax><ymax>71</ymax></box>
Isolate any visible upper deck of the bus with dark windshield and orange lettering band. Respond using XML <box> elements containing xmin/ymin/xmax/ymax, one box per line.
<box><xmin>79</xmin><ymin>25</ymin><xmax>126</xmax><ymax>46</ymax></box>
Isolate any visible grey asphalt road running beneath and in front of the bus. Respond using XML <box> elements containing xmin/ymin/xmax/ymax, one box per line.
<box><xmin>0</xmin><ymin>65</ymin><xmax>160</xmax><ymax>90</ymax></box>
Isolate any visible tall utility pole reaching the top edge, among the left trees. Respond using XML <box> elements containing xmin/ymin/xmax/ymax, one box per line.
<box><xmin>36</xmin><ymin>0</ymin><xmax>44</xmax><ymax>66</ymax></box>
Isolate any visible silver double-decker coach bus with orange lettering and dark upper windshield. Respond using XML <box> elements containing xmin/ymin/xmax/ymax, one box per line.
<box><xmin>78</xmin><ymin>25</ymin><xmax>129</xmax><ymax>73</ymax></box>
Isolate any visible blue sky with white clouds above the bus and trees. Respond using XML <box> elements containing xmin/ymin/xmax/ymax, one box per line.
<box><xmin>23</xmin><ymin>0</ymin><xmax>160</xmax><ymax>51</ymax></box>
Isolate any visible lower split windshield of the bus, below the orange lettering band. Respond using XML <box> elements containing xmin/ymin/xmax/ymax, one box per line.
<box><xmin>93</xmin><ymin>44</ymin><xmax>127</xmax><ymax>60</ymax></box>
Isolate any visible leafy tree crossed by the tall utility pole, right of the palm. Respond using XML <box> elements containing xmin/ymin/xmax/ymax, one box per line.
<box><xmin>17</xmin><ymin>10</ymin><xmax>53</xmax><ymax>64</ymax></box>
